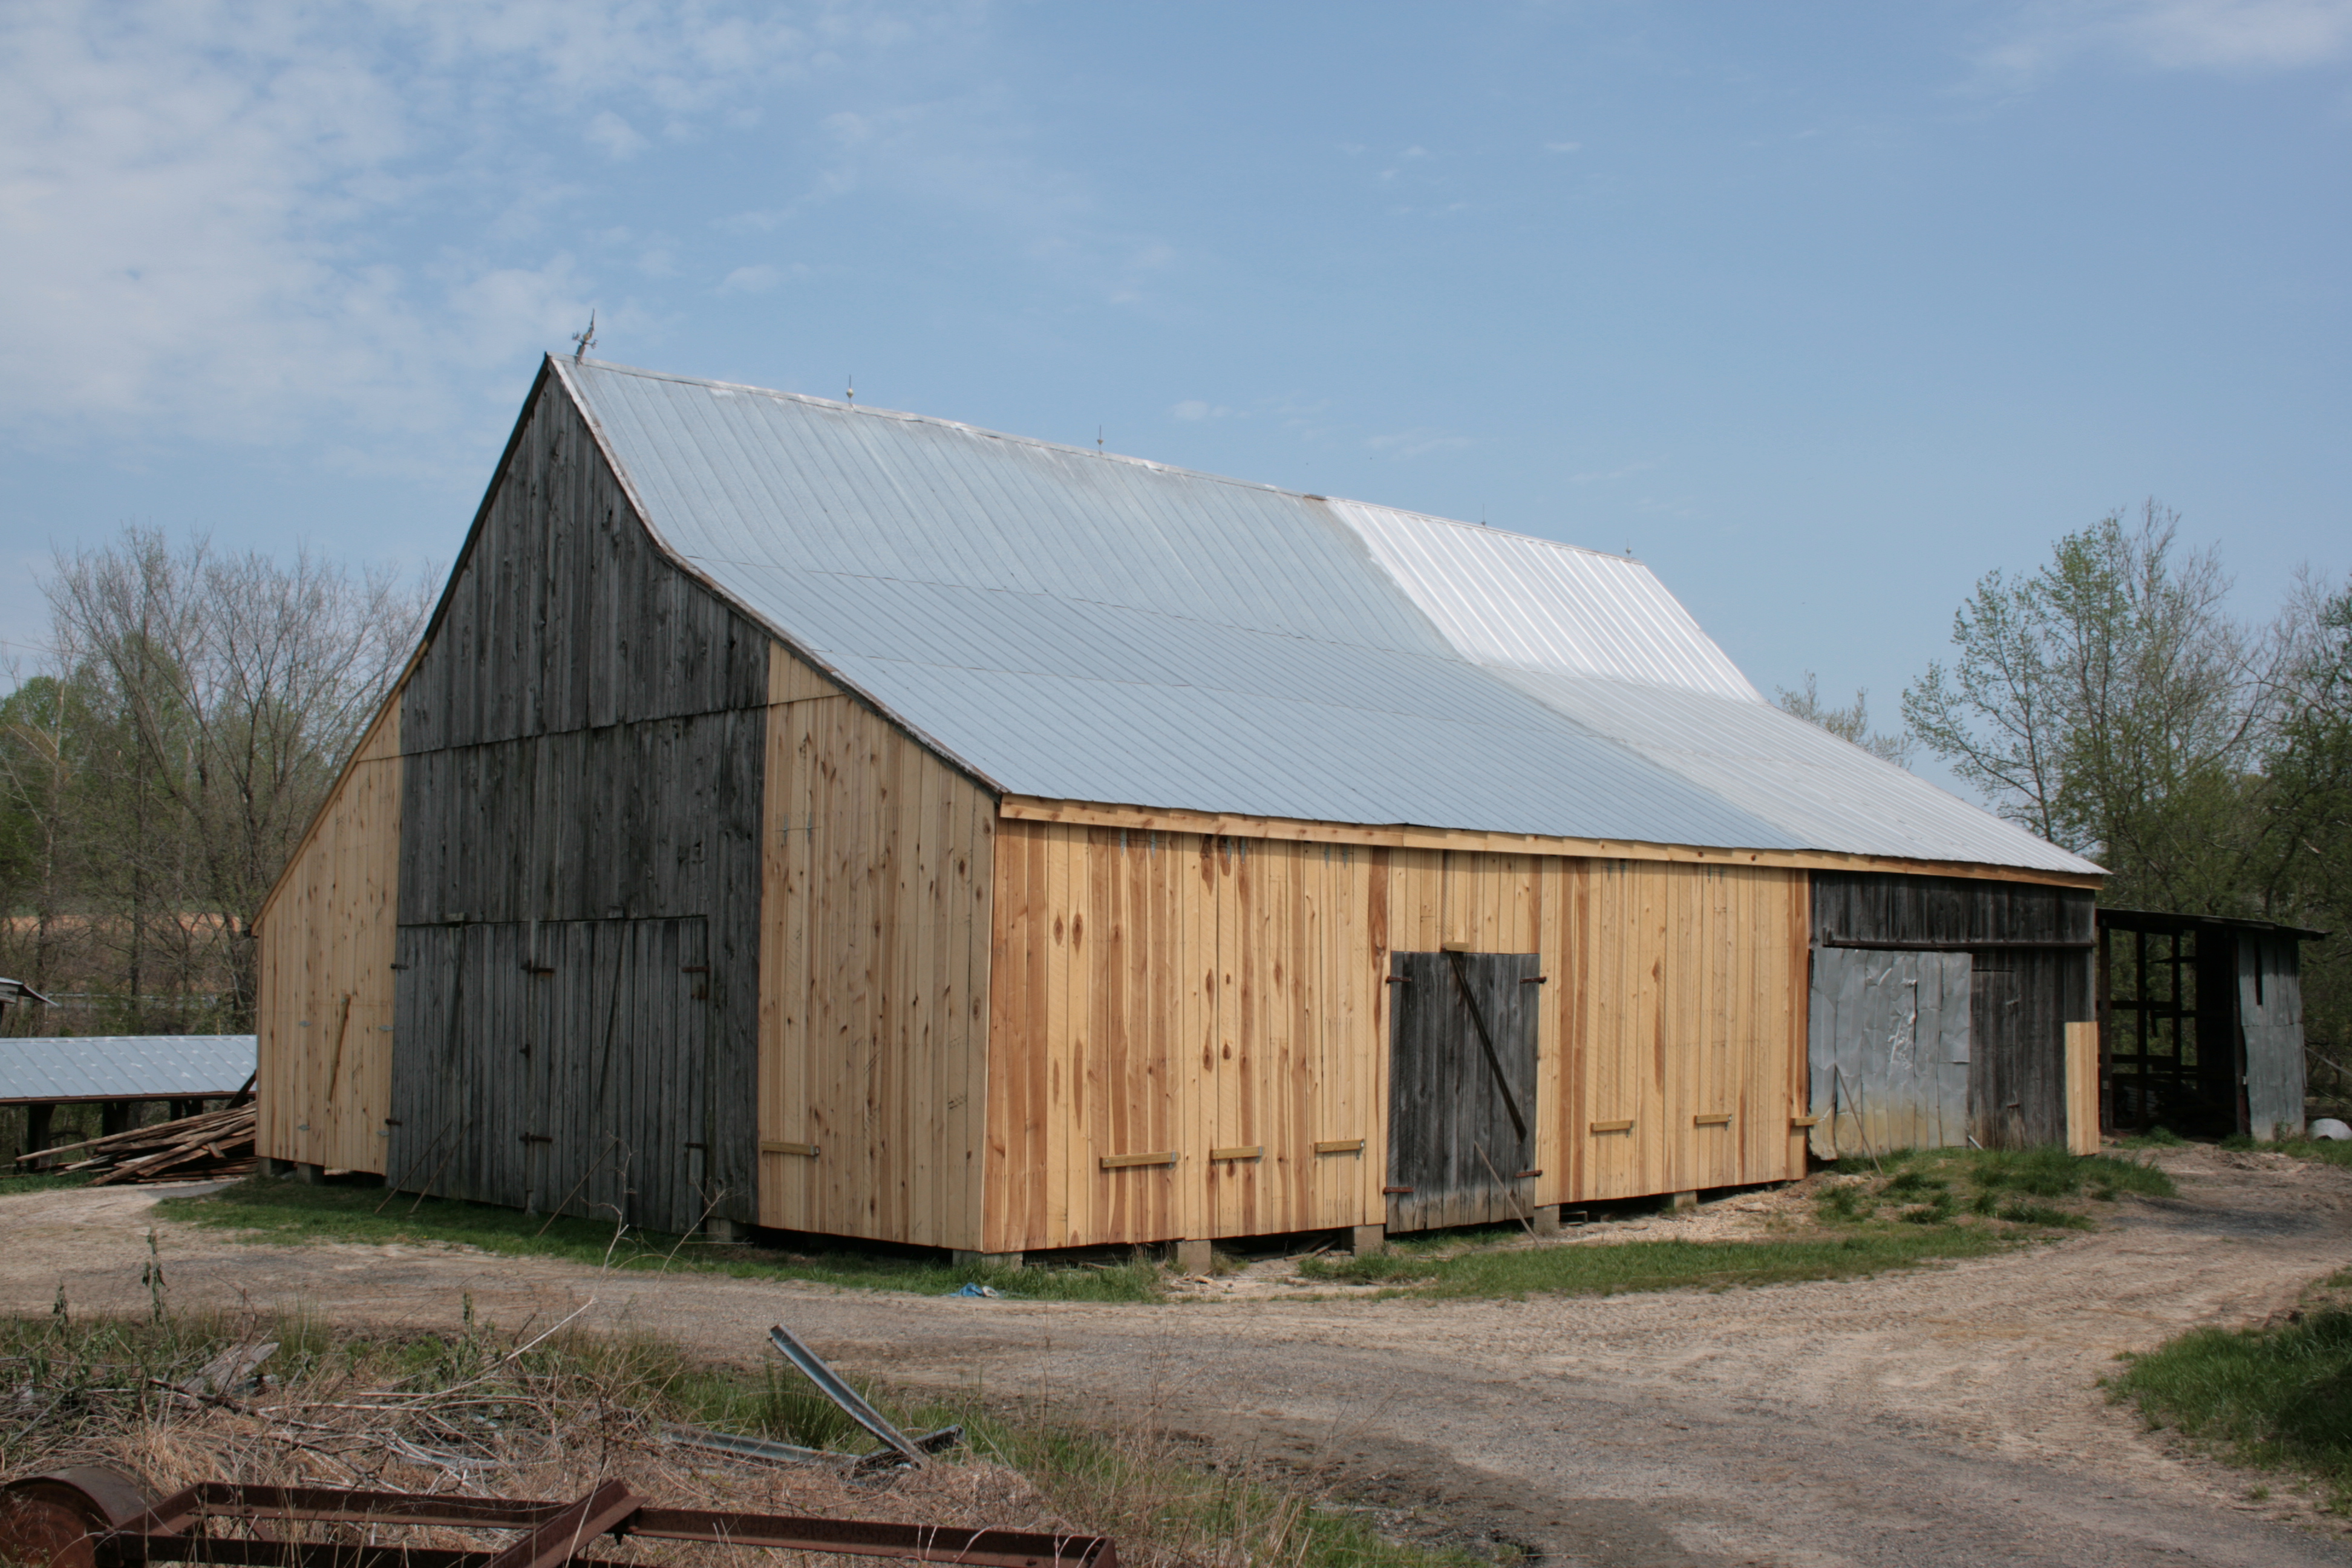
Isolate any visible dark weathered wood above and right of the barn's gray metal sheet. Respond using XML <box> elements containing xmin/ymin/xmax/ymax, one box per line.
<box><xmin>1814</xmin><ymin>872</ymin><xmax>2096</xmax><ymax>1147</ymax></box>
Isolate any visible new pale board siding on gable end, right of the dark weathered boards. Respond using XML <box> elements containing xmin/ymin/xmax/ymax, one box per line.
<box><xmin>760</xmin><ymin>649</ymin><xmax>995</xmax><ymax>1250</ymax></box>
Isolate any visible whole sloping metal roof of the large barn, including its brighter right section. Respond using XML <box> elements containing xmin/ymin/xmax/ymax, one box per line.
<box><xmin>555</xmin><ymin>360</ymin><xmax>2098</xmax><ymax>872</ymax></box>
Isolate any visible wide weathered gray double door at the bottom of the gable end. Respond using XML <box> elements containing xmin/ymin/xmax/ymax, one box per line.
<box><xmin>388</xmin><ymin>917</ymin><xmax>710</xmax><ymax>1232</ymax></box>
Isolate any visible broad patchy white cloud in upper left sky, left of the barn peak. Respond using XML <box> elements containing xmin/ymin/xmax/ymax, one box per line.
<box><xmin>0</xmin><ymin>0</ymin><xmax>912</xmax><ymax>454</ymax></box>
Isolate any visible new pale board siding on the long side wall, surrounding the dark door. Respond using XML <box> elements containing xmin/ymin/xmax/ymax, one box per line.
<box><xmin>983</xmin><ymin>820</ymin><xmax>1806</xmax><ymax>1250</ymax></box>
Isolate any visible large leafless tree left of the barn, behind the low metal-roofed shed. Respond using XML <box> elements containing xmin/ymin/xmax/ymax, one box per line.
<box><xmin>47</xmin><ymin>529</ymin><xmax>428</xmax><ymax>1022</ymax></box>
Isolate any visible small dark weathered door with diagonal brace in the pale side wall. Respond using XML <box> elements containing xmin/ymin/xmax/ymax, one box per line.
<box><xmin>1388</xmin><ymin>952</ymin><xmax>1543</xmax><ymax>1232</ymax></box>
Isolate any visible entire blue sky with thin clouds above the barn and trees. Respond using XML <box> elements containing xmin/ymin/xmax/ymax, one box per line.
<box><xmin>0</xmin><ymin>0</ymin><xmax>2352</xmax><ymax>766</ymax></box>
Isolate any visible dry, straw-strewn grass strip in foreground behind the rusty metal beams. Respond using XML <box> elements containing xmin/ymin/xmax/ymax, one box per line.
<box><xmin>0</xmin><ymin>1310</ymin><xmax>1480</xmax><ymax>1568</ymax></box>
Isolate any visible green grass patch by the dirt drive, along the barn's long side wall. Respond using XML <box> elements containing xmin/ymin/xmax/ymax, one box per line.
<box><xmin>1298</xmin><ymin>1149</ymin><xmax>2175</xmax><ymax>1298</ymax></box>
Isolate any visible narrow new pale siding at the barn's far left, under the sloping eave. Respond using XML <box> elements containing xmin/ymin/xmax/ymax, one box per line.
<box><xmin>254</xmin><ymin>696</ymin><xmax>400</xmax><ymax>1171</ymax></box>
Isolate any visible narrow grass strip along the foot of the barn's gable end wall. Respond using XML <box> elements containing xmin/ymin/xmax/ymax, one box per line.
<box><xmin>155</xmin><ymin>1178</ymin><xmax>1162</xmax><ymax>1302</ymax></box>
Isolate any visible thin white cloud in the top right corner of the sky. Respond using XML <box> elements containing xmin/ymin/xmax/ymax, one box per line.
<box><xmin>1983</xmin><ymin>0</ymin><xmax>2352</xmax><ymax>80</ymax></box>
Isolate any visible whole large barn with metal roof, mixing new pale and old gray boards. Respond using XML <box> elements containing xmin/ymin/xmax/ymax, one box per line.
<box><xmin>259</xmin><ymin>360</ymin><xmax>2100</xmax><ymax>1258</ymax></box>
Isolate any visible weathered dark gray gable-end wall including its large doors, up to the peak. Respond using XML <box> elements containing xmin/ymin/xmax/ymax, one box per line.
<box><xmin>388</xmin><ymin>376</ymin><xmax>769</xmax><ymax>1229</ymax></box>
